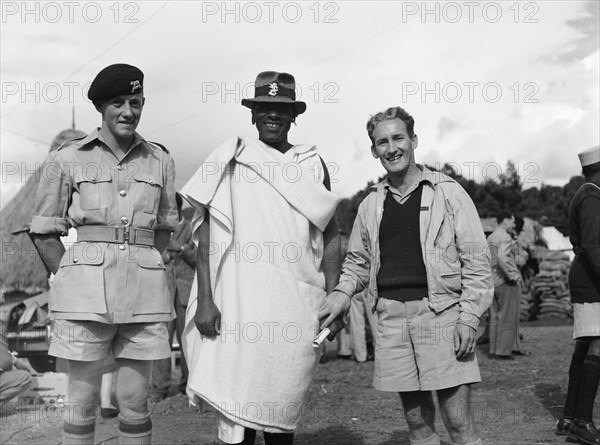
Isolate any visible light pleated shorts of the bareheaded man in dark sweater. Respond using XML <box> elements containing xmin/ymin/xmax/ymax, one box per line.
<box><xmin>373</xmin><ymin>298</ymin><xmax>481</xmax><ymax>392</ymax></box>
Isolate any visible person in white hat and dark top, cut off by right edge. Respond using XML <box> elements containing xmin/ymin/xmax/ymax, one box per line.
<box><xmin>556</xmin><ymin>146</ymin><xmax>600</xmax><ymax>445</ymax></box>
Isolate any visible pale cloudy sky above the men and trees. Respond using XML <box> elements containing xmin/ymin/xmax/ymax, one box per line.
<box><xmin>0</xmin><ymin>1</ymin><xmax>600</xmax><ymax>206</ymax></box>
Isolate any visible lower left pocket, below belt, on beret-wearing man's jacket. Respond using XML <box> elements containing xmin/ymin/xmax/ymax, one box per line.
<box><xmin>49</xmin><ymin>243</ymin><xmax>106</xmax><ymax>314</ymax></box>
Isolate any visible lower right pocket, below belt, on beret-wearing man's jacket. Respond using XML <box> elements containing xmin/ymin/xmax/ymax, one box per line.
<box><xmin>132</xmin><ymin>248</ymin><xmax>173</xmax><ymax>315</ymax></box>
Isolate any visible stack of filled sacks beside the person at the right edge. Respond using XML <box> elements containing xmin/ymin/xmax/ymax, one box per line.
<box><xmin>531</xmin><ymin>250</ymin><xmax>573</xmax><ymax>320</ymax></box>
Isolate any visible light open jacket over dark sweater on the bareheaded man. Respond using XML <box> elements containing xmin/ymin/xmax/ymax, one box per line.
<box><xmin>336</xmin><ymin>166</ymin><xmax>494</xmax><ymax>329</ymax></box>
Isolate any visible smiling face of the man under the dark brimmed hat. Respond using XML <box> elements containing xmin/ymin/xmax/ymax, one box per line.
<box><xmin>252</xmin><ymin>102</ymin><xmax>294</xmax><ymax>151</ymax></box>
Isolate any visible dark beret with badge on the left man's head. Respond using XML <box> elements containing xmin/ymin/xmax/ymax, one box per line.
<box><xmin>88</xmin><ymin>63</ymin><xmax>144</xmax><ymax>101</ymax></box>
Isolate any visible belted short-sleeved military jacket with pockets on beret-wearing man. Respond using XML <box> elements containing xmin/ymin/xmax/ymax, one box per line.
<box><xmin>31</xmin><ymin>130</ymin><xmax>178</xmax><ymax>324</ymax></box>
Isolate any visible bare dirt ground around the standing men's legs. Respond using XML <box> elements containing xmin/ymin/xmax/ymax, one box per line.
<box><xmin>0</xmin><ymin>324</ymin><xmax>600</xmax><ymax>445</ymax></box>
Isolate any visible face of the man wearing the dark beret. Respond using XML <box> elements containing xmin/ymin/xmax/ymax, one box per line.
<box><xmin>96</xmin><ymin>93</ymin><xmax>144</xmax><ymax>141</ymax></box>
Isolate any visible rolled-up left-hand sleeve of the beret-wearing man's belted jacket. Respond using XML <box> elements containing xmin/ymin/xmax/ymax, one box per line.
<box><xmin>30</xmin><ymin>151</ymin><xmax>71</xmax><ymax>236</ymax></box>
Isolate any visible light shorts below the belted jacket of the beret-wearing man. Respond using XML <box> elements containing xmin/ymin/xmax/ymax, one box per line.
<box><xmin>48</xmin><ymin>320</ymin><xmax>171</xmax><ymax>362</ymax></box>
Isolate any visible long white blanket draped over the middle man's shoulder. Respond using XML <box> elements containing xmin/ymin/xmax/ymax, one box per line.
<box><xmin>182</xmin><ymin>138</ymin><xmax>339</xmax><ymax>432</ymax></box>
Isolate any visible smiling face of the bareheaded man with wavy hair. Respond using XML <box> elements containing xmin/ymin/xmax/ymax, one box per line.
<box><xmin>371</xmin><ymin>119</ymin><xmax>418</xmax><ymax>182</ymax></box>
